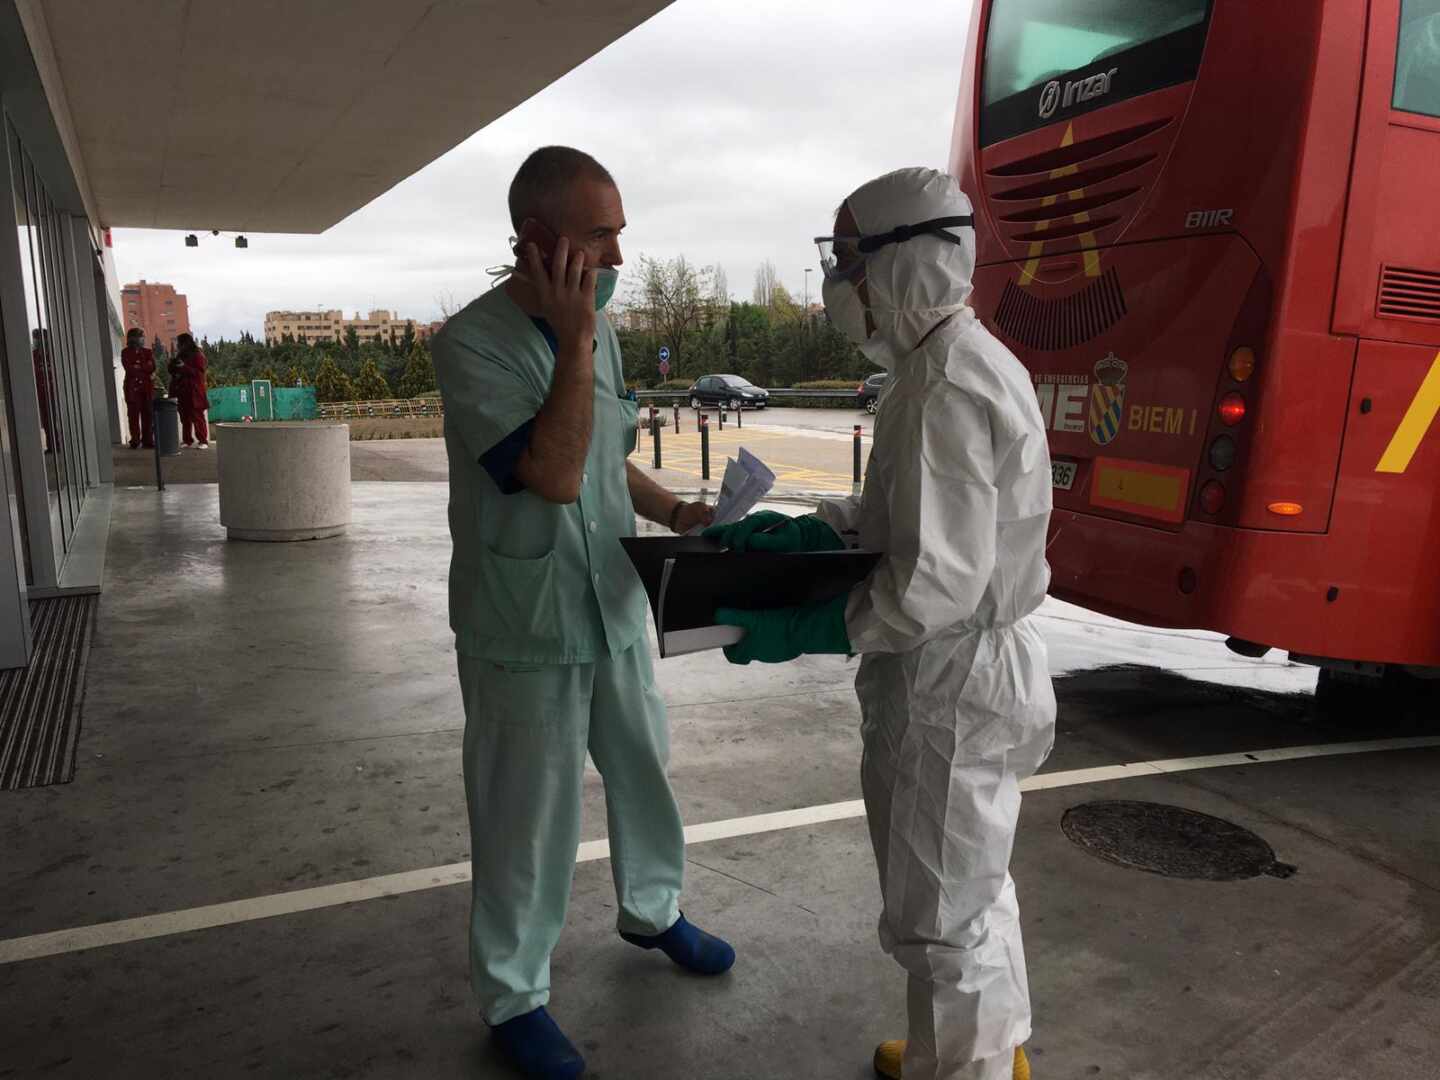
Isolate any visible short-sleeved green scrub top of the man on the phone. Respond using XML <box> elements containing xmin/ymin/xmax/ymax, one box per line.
<box><xmin>431</xmin><ymin>287</ymin><xmax>648</xmax><ymax>664</ymax></box>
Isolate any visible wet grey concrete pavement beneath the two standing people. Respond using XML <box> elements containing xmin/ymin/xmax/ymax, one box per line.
<box><xmin>0</xmin><ymin>482</ymin><xmax>1440</xmax><ymax>1080</ymax></box>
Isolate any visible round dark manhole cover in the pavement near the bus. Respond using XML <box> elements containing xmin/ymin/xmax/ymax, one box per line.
<box><xmin>1060</xmin><ymin>802</ymin><xmax>1295</xmax><ymax>881</ymax></box>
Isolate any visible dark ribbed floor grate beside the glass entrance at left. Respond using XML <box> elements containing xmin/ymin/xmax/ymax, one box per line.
<box><xmin>0</xmin><ymin>596</ymin><xmax>96</xmax><ymax>791</ymax></box>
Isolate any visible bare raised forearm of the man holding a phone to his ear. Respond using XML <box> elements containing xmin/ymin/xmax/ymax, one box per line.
<box><xmin>516</xmin><ymin>341</ymin><xmax>595</xmax><ymax>503</ymax></box>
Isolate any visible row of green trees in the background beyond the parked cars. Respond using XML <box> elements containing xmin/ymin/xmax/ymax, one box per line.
<box><xmin>180</xmin><ymin>255</ymin><xmax>876</xmax><ymax>402</ymax></box>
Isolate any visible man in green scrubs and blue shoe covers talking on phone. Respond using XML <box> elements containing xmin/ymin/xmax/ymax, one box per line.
<box><xmin>432</xmin><ymin>147</ymin><xmax>734</xmax><ymax>1080</ymax></box>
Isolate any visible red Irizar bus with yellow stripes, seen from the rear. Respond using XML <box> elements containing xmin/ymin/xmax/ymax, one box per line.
<box><xmin>950</xmin><ymin>0</ymin><xmax>1440</xmax><ymax>705</ymax></box>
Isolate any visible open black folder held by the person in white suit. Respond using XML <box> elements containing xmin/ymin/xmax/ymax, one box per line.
<box><xmin>621</xmin><ymin>536</ymin><xmax>880</xmax><ymax>657</ymax></box>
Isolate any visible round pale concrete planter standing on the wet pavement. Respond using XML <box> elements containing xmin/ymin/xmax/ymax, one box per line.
<box><xmin>215</xmin><ymin>422</ymin><xmax>350</xmax><ymax>541</ymax></box>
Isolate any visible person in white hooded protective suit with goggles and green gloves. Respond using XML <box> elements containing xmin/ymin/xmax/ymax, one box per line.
<box><xmin>707</xmin><ymin>168</ymin><xmax>1056</xmax><ymax>1080</ymax></box>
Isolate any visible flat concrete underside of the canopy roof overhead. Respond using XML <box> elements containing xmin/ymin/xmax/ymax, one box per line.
<box><xmin>40</xmin><ymin>0</ymin><xmax>670</xmax><ymax>232</ymax></box>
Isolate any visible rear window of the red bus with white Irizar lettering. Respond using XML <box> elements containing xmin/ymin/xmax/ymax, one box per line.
<box><xmin>981</xmin><ymin>0</ymin><xmax>1210</xmax><ymax>145</ymax></box>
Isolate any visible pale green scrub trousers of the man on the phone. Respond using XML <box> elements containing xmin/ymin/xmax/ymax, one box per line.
<box><xmin>459</xmin><ymin>638</ymin><xmax>685</xmax><ymax>1025</ymax></box>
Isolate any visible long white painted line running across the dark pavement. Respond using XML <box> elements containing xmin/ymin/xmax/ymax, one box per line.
<box><xmin>0</xmin><ymin>736</ymin><xmax>1440</xmax><ymax>965</ymax></box>
